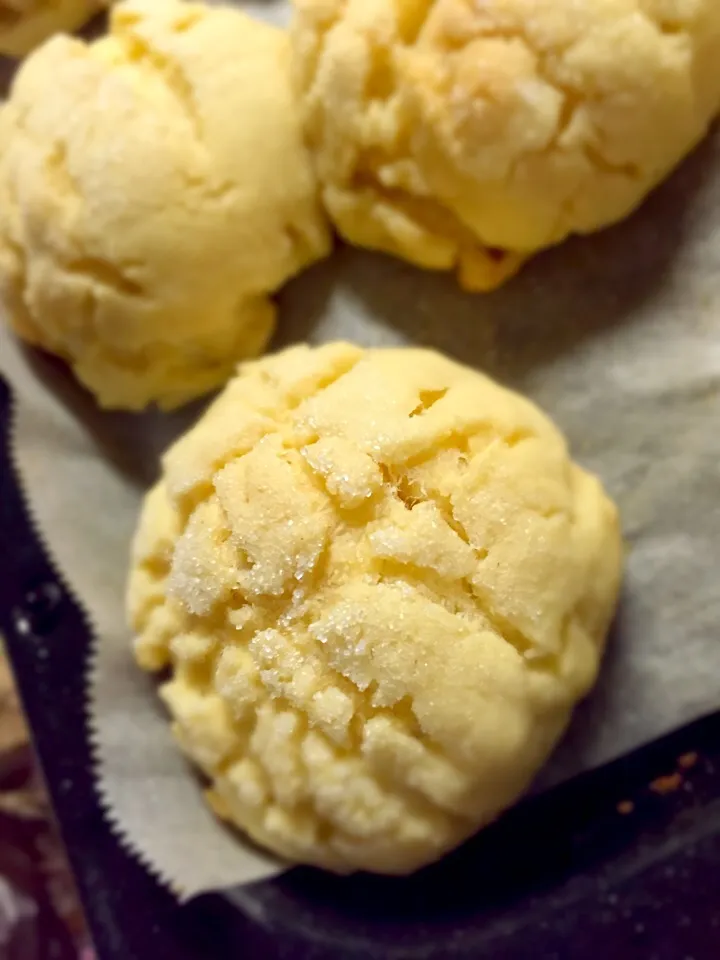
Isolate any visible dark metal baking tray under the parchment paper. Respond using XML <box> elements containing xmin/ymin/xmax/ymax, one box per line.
<box><xmin>0</xmin><ymin>380</ymin><xmax>720</xmax><ymax>960</ymax></box>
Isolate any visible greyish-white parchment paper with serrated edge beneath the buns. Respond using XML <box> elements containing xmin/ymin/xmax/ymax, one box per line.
<box><xmin>0</xmin><ymin>2</ymin><xmax>720</xmax><ymax>897</ymax></box>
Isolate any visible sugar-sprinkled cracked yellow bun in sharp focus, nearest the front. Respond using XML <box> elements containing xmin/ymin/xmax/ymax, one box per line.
<box><xmin>129</xmin><ymin>343</ymin><xmax>621</xmax><ymax>873</ymax></box>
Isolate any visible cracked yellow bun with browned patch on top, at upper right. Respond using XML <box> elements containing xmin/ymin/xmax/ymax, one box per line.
<box><xmin>293</xmin><ymin>0</ymin><xmax>720</xmax><ymax>290</ymax></box>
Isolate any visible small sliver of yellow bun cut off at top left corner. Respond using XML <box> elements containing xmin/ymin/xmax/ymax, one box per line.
<box><xmin>0</xmin><ymin>0</ymin><xmax>102</xmax><ymax>57</ymax></box>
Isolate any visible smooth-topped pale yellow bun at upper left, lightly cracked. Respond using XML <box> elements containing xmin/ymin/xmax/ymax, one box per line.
<box><xmin>0</xmin><ymin>0</ymin><xmax>330</xmax><ymax>409</ymax></box>
